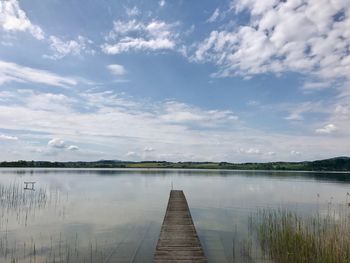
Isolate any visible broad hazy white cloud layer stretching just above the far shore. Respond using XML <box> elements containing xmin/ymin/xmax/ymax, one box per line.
<box><xmin>0</xmin><ymin>90</ymin><xmax>350</xmax><ymax>162</ymax></box>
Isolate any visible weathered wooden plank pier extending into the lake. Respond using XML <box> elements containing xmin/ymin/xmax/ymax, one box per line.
<box><xmin>153</xmin><ymin>190</ymin><xmax>208</xmax><ymax>263</ymax></box>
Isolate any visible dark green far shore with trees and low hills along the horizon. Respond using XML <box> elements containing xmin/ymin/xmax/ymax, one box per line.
<box><xmin>0</xmin><ymin>157</ymin><xmax>350</xmax><ymax>172</ymax></box>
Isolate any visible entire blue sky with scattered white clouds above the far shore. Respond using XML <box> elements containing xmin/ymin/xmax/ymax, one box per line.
<box><xmin>0</xmin><ymin>0</ymin><xmax>350</xmax><ymax>162</ymax></box>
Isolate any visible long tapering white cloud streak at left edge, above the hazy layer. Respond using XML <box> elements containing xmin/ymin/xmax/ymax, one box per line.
<box><xmin>0</xmin><ymin>60</ymin><xmax>77</xmax><ymax>87</ymax></box>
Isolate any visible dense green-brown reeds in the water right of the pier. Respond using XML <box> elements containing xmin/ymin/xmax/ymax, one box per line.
<box><xmin>253</xmin><ymin>206</ymin><xmax>350</xmax><ymax>263</ymax></box>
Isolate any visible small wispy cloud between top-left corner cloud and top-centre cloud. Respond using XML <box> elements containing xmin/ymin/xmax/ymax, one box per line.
<box><xmin>44</xmin><ymin>36</ymin><xmax>95</xmax><ymax>59</ymax></box>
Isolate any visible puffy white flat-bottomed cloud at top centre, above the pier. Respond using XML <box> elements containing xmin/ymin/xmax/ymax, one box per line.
<box><xmin>102</xmin><ymin>19</ymin><xmax>178</xmax><ymax>54</ymax></box>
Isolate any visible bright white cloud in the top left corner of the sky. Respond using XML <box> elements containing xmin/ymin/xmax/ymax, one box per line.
<box><xmin>0</xmin><ymin>0</ymin><xmax>45</xmax><ymax>40</ymax></box>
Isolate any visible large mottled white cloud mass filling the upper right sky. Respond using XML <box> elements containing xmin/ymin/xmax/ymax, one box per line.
<box><xmin>188</xmin><ymin>0</ymin><xmax>350</xmax><ymax>142</ymax></box>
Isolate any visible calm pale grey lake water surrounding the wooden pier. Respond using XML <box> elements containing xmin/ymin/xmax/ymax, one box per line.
<box><xmin>0</xmin><ymin>169</ymin><xmax>350</xmax><ymax>262</ymax></box>
